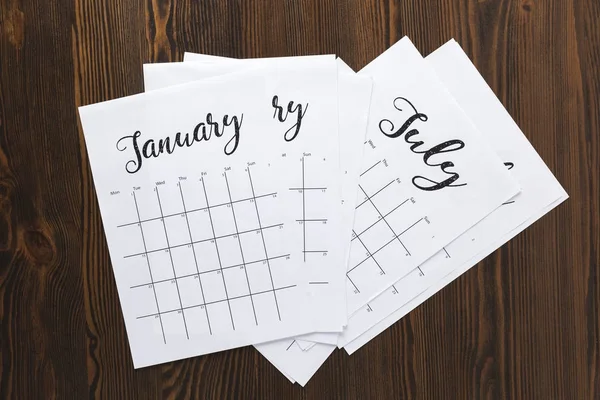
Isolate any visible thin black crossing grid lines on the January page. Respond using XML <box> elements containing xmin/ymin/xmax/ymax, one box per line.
<box><xmin>117</xmin><ymin>167</ymin><xmax>290</xmax><ymax>344</ymax></box>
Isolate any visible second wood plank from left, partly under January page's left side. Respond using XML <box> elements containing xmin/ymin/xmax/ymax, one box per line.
<box><xmin>70</xmin><ymin>0</ymin><xmax>164</xmax><ymax>398</ymax></box>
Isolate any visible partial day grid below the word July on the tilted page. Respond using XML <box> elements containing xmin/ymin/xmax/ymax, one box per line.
<box><xmin>346</xmin><ymin>159</ymin><xmax>430</xmax><ymax>294</ymax></box>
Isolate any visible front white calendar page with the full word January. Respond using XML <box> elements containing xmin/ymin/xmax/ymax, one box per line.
<box><xmin>80</xmin><ymin>71</ymin><xmax>330</xmax><ymax>367</ymax></box>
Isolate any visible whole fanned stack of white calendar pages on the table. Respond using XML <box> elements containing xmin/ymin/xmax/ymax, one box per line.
<box><xmin>79</xmin><ymin>38</ymin><xmax>568</xmax><ymax>385</ymax></box>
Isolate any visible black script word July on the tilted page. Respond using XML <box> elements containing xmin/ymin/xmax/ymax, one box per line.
<box><xmin>379</xmin><ymin>97</ymin><xmax>466</xmax><ymax>191</ymax></box>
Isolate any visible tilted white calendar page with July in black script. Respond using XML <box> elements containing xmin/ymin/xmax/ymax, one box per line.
<box><xmin>347</xmin><ymin>37</ymin><xmax>519</xmax><ymax>315</ymax></box>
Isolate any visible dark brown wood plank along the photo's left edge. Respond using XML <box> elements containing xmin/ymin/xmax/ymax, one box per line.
<box><xmin>0</xmin><ymin>0</ymin><xmax>87</xmax><ymax>398</ymax></box>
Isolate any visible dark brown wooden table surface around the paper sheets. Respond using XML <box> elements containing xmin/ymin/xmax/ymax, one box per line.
<box><xmin>0</xmin><ymin>0</ymin><xmax>600</xmax><ymax>399</ymax></box>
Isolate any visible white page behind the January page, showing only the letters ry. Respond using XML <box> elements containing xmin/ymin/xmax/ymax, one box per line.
<box><xmin>144</xmin><ymin>60</ymin><xmax>347</xmax><ymax>332</ymax></box>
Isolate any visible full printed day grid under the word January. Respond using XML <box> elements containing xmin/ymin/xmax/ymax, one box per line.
<box><xmin>118</xmin><ymin>166</ymin><xmax>296</xmax><ymax>344</ymax></box>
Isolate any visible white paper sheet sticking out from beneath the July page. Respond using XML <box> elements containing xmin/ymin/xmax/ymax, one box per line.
<box><xmin>339</xmin><ymin>37</ymin><xmax>568</xmax><ymax>352</ymax></box>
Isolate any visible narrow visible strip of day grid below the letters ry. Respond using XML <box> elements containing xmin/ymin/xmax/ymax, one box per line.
<box><xmin>289</xmin><ymin>153</ymin><xmax>328</xmax><ymax>262</ymax></box>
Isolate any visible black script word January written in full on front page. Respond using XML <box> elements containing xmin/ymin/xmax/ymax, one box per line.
<box><xmin>116</xmin><ymin>113</ymin><xmax>244</xmax><ymax>174</ymax></box>
